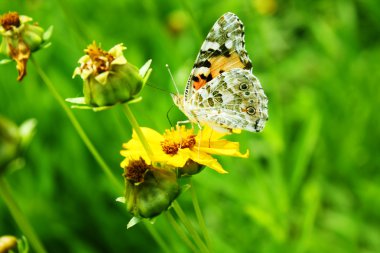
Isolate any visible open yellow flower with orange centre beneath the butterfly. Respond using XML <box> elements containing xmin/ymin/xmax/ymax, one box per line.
<box><xmin>120</xmin><ymin>126</ymin><xmax>249</xmax><ymax>173</ymax></box>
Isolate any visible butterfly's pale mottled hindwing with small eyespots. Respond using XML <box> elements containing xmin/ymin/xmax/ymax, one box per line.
<box><xmin>188</xmin><ymin>69</ymin><xmax>268</xmax><ymax>132</ymax></box>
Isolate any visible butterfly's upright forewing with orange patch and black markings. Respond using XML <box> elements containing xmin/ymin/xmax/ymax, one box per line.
<box><xmin>184</xmin><ymin>12</ymin><xmax>252</xmax><ymax>103</ymax></box>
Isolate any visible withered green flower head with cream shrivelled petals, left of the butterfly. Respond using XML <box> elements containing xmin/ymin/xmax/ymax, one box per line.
<box><xmin>66</xmin><ymin>42</ymin><xmax>151</xmax><ymax>110</ymax></box>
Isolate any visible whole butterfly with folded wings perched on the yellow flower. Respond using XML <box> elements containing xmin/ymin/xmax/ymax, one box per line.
<box><xmin>172</xmin><ymin>12</ymin><xmax>268</xmax><ymax>132</ymax></box>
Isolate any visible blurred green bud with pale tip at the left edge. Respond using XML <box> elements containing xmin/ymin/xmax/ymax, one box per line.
<box><xmin>0</xmin><ymin>116</ymin><xmax>36</xmax><ymax>174</ymax></box>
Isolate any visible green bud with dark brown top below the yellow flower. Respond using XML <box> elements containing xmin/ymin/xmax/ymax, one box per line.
<box><xmin>124</xmin><ymin>158</ymin><xmax>180</xmax><ymax>218</ymax></box>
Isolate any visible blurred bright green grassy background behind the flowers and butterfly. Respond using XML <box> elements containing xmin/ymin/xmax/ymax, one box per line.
<box><xmin>0</xmin><ymin>0</ymin><xmax>380</xmax><ymax>253</ymax></box>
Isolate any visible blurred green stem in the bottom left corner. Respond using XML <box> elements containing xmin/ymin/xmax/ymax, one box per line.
<box><xmin>0</xmin><ymin>176</ymin><xmax>47</xmax><ymax>253</ymax></box>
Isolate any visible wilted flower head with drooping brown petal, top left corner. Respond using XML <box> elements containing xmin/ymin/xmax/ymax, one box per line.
<box><xmin>0</xmin><ymin>12</ymin><xmax>53</xmax><ymax>81</ymax></box>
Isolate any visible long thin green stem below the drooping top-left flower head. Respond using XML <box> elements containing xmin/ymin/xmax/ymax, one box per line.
<box><xmin>31</xmin><ymin>57</ymin><xmax>124</xmax><ymax>191</ymax></box>
